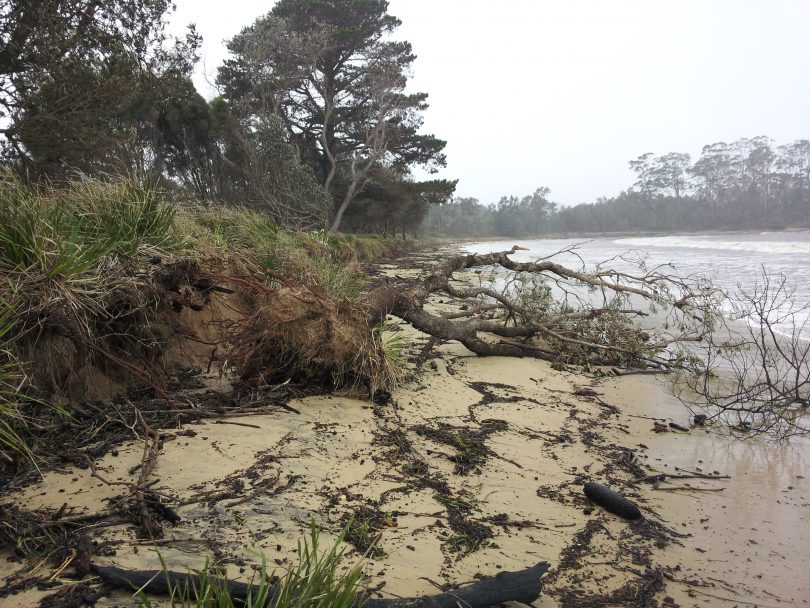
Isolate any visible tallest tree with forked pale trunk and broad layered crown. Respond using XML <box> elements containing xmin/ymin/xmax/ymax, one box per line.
<box><xmin>217</xmin><ymin>0</ymin><xmax>446</xmax><ymax>231</ymax></box>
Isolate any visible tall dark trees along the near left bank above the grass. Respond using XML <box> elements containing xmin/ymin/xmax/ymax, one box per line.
<box><xmin>0</xmin><ymin>0</ymin><xmax>455</xmax><ymax>233</ymax></box>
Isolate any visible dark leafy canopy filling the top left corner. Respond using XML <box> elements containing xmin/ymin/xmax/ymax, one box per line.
<box><xmin>0</xmin><ymin>0</ymin><xmax>200</xmax><ymax>176</ymax></box>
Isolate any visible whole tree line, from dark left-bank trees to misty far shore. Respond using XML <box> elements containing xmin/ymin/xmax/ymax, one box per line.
<box><xmin>0</xmin><ymin>0</ymin><xmax>810</xmax><ymax>236</ymax></box>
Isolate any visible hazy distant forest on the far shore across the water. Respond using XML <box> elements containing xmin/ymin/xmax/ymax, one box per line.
<box><xmin>425</xmin><ymin>136</ymin><xmax>810</xmax><ymax>236</ymax></box>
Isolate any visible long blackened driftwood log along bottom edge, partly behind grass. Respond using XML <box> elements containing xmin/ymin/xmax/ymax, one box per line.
<box><xmin>92</xmin><ymin>562</ymin><xmax>549</xmax><ymax>608</ymax></box>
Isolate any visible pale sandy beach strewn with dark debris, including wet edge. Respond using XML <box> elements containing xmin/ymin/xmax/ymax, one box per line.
<box><xmin>0</xmin><ymin>247</ymin><xmax>810</xmax><ymax>608</ymax></box>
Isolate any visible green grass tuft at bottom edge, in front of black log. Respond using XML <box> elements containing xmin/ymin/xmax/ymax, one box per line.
<box><xmin>140</xmin><ymin>521</ymin><xmax>363</xmax><ymax>608</ymax></box>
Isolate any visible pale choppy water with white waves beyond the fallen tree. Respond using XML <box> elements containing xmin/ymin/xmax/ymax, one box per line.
<box><xmin>464</xmin><ymin>231</ymin><xmax>810</xmax><ymax>339</ymax></box>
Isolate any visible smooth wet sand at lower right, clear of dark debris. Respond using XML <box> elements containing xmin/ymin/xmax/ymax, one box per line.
<box><xmin>603</xmin><ymin>377</ymin><xmax>810</xmax><ymax>606</ymax></box>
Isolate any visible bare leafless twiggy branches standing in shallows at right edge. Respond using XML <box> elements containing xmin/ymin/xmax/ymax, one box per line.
<box><xmin>676</xmin><ymin>270</ymin><xmax>810</xmax><ymax>438</ymax></box>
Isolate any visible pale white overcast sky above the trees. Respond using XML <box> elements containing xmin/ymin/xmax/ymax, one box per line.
<box><xmin>166</xmin><ymin>0</ymin><xmax>810</xmax><ymax>204</ymax></box>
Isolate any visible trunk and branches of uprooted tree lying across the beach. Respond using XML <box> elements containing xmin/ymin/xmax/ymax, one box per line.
<box><xmin>376</xmin><ymin>246</ymin><xmax>717</xmax><ymax>371</ymax></box>
